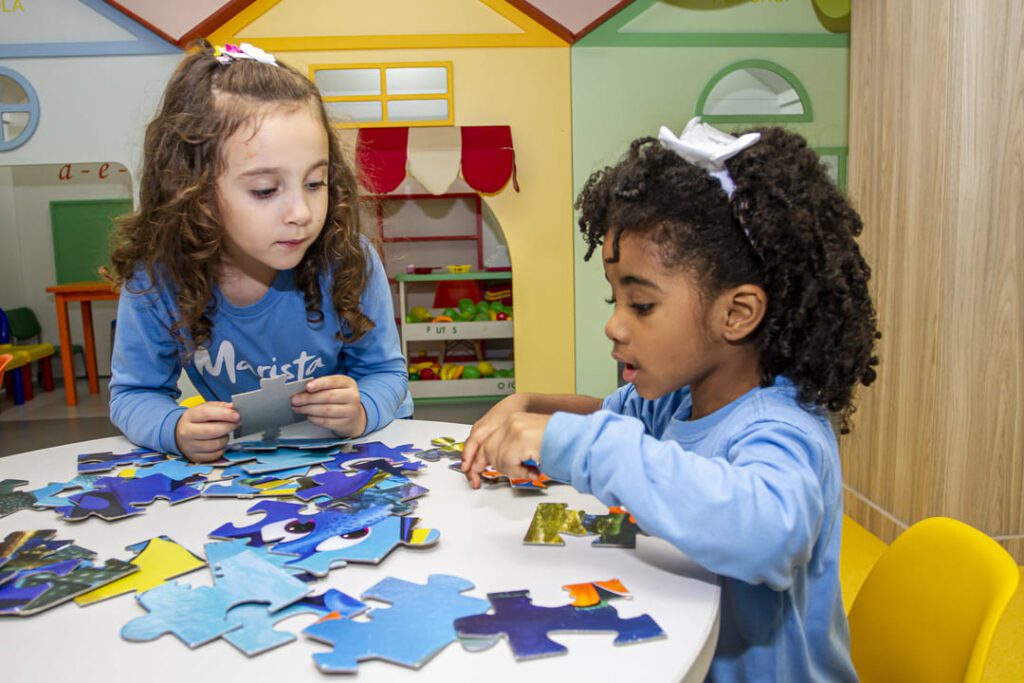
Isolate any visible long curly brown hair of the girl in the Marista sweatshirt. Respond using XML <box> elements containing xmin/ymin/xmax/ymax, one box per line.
<box><xmin>111</xmin><ymin>41</ymin><xmax>374</xmax><ymax>356</ymax></box>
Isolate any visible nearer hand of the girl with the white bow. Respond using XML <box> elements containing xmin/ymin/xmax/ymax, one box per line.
<box><xmin>462</xmin><ymin>405</ymin><xmax>551</xmax><ymax>488</ymax></box>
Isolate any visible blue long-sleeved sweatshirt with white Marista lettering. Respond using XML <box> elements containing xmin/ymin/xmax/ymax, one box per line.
<box><xmin>111</xmin><ymin>245</ymin><xmax>413</xmax><ymax>454</ymax></box>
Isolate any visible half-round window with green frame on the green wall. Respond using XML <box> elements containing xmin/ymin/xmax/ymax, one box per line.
<box><xmin>696</xmin><ymin>59</ymin><xmax>814</xmax><ymax>123</ymax></box>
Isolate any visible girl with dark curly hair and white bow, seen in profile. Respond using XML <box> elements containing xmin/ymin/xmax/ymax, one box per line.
<box><xmin>463</xmin><ymin>120</ymin><xmax>878</xmax><ymax>681</ymax></box>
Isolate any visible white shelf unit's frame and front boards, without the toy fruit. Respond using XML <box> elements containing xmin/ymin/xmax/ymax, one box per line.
<box><xmin>395</xmin><ymin>271</ymin><xmax>515</xmax><ymax>399</ymax></box>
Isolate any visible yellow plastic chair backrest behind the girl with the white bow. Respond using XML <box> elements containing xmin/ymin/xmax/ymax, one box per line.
<box><xmin>849</xmin><ymin>517</ymin><xmax>1020</xmax><ymax>683</ymax></box>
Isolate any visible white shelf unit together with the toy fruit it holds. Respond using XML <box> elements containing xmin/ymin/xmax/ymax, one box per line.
<box><xmin>395</xmin><ymin>266</ymin><xmax>515</xmax><ymax>399</ymax></box>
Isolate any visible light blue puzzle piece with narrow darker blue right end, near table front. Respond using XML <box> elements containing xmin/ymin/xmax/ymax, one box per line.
<box><xmin>223</xmin><ymin>589</ymin><xmax>367</xmax><ymax>656</ymax></box>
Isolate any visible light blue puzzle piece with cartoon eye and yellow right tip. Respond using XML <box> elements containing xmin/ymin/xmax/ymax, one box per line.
<box><xmin>284</xmin><ymin>517</ymin><xmax>441</xmax><ymax>577</ymax></box>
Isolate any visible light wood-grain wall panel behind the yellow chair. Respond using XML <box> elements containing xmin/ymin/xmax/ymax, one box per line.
<box><xmin>843</xmin><ymin>0</ymin><xmax>1024</xmax><ymax>561</ymax></box>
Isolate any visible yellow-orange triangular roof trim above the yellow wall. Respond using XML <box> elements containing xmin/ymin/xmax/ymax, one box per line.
<box><xmin>208</xmin><ymin>0</ymin><xmax>568</xmax><ymax>52</ymax></box>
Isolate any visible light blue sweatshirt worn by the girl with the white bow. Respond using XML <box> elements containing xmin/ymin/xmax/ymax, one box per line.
<box><xmin>541</xmin><ymin>378</ymin><xmax>857</xmax><ymax>681</ymax></box>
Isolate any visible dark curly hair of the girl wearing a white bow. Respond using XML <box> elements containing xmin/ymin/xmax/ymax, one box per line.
<box><xmin>575</xmin><ymin>127</ymin><xmax>880</xmax><ymax>432</ymax></box>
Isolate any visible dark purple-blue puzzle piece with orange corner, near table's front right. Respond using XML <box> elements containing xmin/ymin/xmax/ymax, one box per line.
<box><xmin>455</xmin><ymin>580</ymin><xmax>665</xmax><ymax>659</ymax></box>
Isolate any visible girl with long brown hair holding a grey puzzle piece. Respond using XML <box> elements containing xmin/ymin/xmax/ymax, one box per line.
<box><xmin>104</xmin><ymin>44</ymin><xmax>412</xmax><ymax>462</ymax></box>
